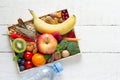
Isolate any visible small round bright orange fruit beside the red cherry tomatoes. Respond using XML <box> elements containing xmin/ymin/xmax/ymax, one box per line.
<box><xmin>32</xmin><ymin>53</ymin><xmax>46</xmax><ymax>66</ymax></box>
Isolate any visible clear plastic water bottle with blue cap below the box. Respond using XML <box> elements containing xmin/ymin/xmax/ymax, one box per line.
<box><xmin>20</xmin><ymin>63</ymin><xmax>63</xmax><ymax>80</ymax></box>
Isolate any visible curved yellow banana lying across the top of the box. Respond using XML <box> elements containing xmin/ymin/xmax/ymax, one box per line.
<box><xmin>29</xmin><ymin>10</ymin><xmax>76</xmax><ymax>35</ymax></box>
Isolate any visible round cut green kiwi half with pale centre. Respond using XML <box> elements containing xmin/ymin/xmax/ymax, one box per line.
<box><xmin>12</xmin><ymin>38</ymin><xmax>26</xmax><ymax>53</ymax></box>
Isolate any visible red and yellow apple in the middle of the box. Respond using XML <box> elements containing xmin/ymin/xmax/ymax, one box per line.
<box><xmin>37</xmin><ymin>33</ymin><xmax>57</xmax><ymax>54</ymax></box>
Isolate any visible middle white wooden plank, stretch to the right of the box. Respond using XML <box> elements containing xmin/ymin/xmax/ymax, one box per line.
<box><xmin>75</xmin><ymin>26</ymin><xmax>120</xmax><ymax>53</ymax></box>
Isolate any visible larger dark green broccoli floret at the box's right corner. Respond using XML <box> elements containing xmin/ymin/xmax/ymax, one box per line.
<box><xmin>67</xmin><ymin>42</ymin><xmax>80</xmax><ymax>55</ymax></box>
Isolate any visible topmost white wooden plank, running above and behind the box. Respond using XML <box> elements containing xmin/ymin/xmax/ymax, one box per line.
<box><xmin>0</xmin><ymin>0</ymin><xmax>120</xmax><ymax>25</ymax></box>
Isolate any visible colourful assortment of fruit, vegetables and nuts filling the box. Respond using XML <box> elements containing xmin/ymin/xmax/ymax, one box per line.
<box><xmin>8</xmin><ymin>9</ymin><xmax>80</xmax><ymax>71</ymax></box>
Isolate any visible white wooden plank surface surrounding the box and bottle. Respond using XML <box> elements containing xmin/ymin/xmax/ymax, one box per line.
<box><xmin>0</xmin><ymin>0</ymin><xmax>120</xmax><ymax>80</ymax></box>
